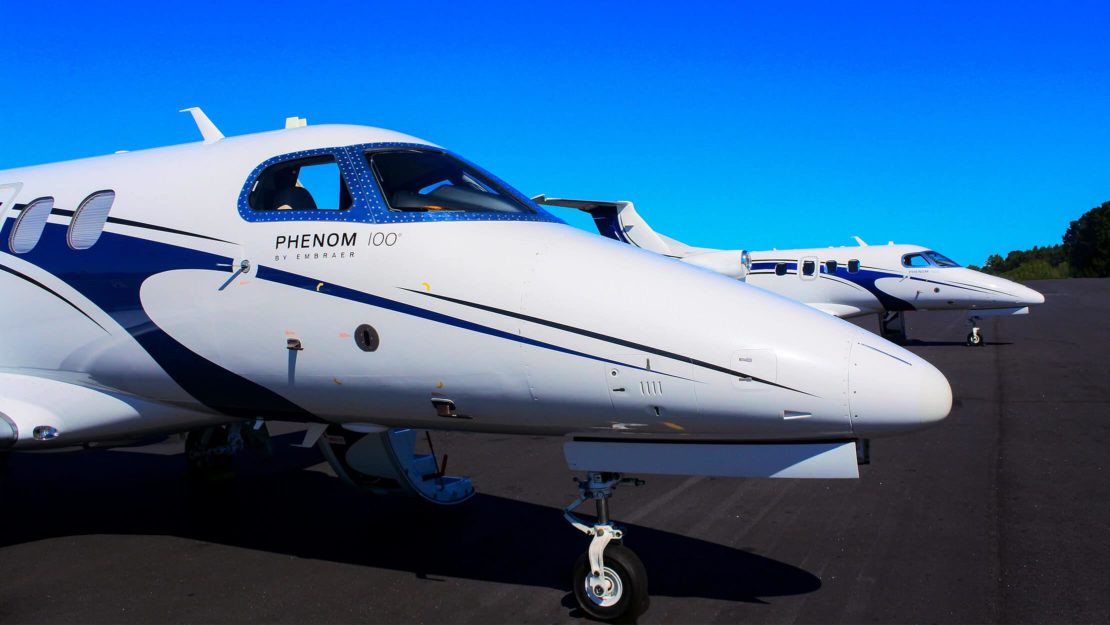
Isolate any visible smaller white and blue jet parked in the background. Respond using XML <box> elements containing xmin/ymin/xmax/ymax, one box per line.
<box><xmin>546</xmin><ymin>195</ymin><xmax>1045</xmax><ymax>345</ymax></box>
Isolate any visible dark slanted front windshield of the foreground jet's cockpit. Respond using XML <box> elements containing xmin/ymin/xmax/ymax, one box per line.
<box><xmin>366</xmin><ymin>149</ymin><xmax>535</xmax><ymax>214</ymax></box>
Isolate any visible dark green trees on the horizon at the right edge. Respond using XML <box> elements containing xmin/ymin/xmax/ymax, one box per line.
<box><xmin>969</xmin><ymin>202</ymin><xmax>1110</xmax><ymax>280</ymax></box>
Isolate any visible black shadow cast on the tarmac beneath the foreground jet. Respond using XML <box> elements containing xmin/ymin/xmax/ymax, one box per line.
<box><xmin>0</xmin><ymin>435</ymin><xmax>821</xmax><ymax>603</ymax></box>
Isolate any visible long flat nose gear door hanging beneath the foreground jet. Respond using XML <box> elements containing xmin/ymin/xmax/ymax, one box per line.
<box><xmin>563</xmin><ymin>440</ymin><xmax>859</xmax><ymax>478</ymax></box>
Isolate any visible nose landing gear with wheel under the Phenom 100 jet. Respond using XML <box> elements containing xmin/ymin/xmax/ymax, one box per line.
<box><xmin>563</xmin><ymin>473</ymin><xmax>649</xmax><ymax>621</ymax></box>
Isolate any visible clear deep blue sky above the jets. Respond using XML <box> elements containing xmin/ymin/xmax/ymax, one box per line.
<box><xmin>0</xmin><ymin>0</ymin><xmax>1110</xmax><ymax>263</ymax></box>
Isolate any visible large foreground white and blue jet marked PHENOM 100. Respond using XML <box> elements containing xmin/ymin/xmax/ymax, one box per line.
<box><xmin>0</xmin><ymin>110</ymin><xmax>951</xmax><ymax>618</ymax></box>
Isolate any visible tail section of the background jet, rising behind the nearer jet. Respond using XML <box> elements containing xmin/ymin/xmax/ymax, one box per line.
<box><xmin>532</xmin><ymin>195</ymin><xmax>748</xmax><ymax>280</ymax></box>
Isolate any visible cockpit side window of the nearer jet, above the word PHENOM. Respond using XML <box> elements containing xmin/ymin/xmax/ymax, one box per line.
<box><xmin>248</xmin><ymin>154</ymin><xmax>353</xmax><ymax>211</ymax></box>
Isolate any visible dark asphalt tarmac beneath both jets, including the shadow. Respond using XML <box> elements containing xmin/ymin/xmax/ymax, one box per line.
<box><xmin>0</xmin><ymin>280</ymin><xmax>1110</xmax><ymax>624</ymax></box>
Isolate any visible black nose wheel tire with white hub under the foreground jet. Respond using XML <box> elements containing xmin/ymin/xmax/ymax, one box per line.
<box><xmin>572</xmin><ymin>543</ymin><xmax>650</xmax><ymax>622</ymax></box>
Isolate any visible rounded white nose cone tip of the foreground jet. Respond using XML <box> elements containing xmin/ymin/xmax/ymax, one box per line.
<box><xmin>848</xmin><ymin>341</ymin><xmax>952</xmax><ymax>438</ymax></box>
